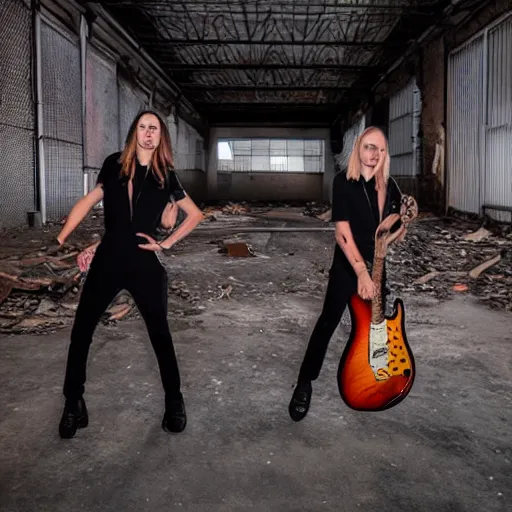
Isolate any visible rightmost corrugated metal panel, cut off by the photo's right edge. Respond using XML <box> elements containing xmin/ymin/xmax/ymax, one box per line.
<box><xmin>484</xmin><ymin>17</ymin><xmax>512</xmax><ymax>220</ymax></box>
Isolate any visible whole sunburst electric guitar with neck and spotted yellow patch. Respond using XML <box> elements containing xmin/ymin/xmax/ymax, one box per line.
<box><xmin>338</xmin><ymin>196</ymin><xmax>418</xmax><ymax>411</ymax></box>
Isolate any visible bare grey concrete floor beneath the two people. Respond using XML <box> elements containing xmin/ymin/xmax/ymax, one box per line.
<box><xmin>0</xmin><ymin>217</ymin><xmax>512</xmax><ymax>512</ymax></box>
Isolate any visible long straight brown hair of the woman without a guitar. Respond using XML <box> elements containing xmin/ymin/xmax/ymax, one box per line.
<box><xmin>119</xmin><ymin>110</ymin><xmax>174</xmax><ymax>187</ymax></box>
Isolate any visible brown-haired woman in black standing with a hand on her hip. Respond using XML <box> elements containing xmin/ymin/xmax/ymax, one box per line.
<box><xmin>57</xmin><ymin>110</ymin><xmax>203</xmax><ymax>438</ymax></box>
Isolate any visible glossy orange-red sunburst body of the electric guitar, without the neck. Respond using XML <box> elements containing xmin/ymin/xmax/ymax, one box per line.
<box><xmin>338</xmin><ymin>294</ymin><xmax>415</xmax><ymax>411</ymax></box>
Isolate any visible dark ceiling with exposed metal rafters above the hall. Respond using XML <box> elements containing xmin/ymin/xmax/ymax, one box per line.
<box><xmin>100</xmin><ymin>0</ymin><xmax>450</xmax><ymax>121</ymax></box>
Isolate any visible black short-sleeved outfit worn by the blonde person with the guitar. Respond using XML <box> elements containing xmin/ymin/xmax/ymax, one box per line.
<box><xmin>299</xmin><ymin>172</ymin><xmax>401</xmax><ymax>382</ymax></box>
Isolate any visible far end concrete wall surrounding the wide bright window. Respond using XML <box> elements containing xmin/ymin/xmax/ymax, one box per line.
<box><xmin>207</xmin><ymin>126</ymin><xmax>335</xmax><ymax>201</ymax></box>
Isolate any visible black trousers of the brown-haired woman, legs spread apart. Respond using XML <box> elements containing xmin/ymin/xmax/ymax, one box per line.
<box><xmin>64</xmin><ymin>241</ymin><xmax>181</xmax><ymax>402</ymax></box>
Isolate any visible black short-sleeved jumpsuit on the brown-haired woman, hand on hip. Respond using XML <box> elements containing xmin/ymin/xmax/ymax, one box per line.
<box><xmin>64</xmin><ymin>153</ymin><xmax>185</xmax><ymax>401</ymax></box>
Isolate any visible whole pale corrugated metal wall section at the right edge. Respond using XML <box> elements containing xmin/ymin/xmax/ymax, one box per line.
<box><xmin>447</xmin><ymin>16</ymin><xmax>512</xmax><ymax>220</ymax></box>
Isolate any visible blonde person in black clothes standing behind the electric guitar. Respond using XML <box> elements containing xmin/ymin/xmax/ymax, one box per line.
<box><xmin>289</xmin><ymin>126</ymin><xmax>405</xmax><ymax>421</ymax></box>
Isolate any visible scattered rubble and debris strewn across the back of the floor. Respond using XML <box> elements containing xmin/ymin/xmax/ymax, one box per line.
<box><xmin>0</xmin><ymin>203</ymin><xmax>512</xmax><ymax>334</ymax></box>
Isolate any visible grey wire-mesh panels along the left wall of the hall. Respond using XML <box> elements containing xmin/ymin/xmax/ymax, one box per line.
<box><xmin>0</xmin><ymin>0</ymin><xmax>204</xmax><ymax>224</ymax></box>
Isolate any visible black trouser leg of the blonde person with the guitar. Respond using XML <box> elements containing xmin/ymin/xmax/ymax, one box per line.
<box><xmin>298</xmin><ymin>262</ymin><xmax>386</xmax><ymax>383</ymax></box>
